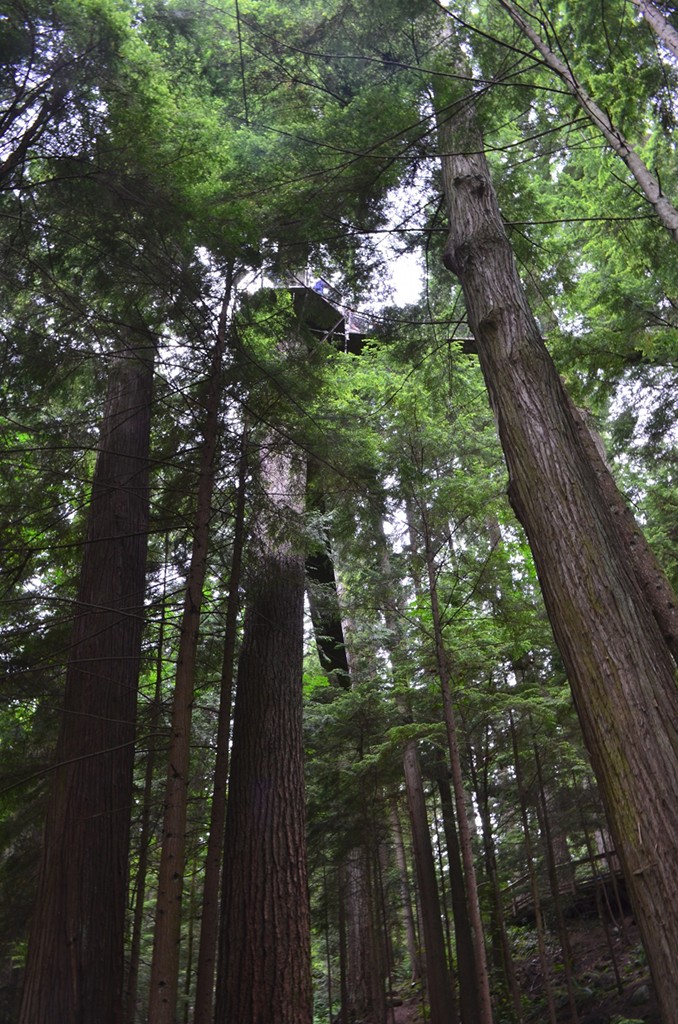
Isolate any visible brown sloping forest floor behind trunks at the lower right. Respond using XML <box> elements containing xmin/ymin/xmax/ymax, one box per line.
<box><xmin>387</xmin><ymin>919</ymin><xmax>661</xmax><ymax>1024</ymax></box>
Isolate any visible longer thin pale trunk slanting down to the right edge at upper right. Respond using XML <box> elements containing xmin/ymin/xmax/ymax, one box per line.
<box><xmin>499</xmin><ymin>0</ymin><xmax>678</xmax><ymax>242</ymax></box>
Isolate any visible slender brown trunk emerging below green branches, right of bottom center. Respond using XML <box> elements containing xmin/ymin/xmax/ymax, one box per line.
<box><xmin>402</xmin><ymin>740</ymin><xmax>458</xmax><ymax>1024</ymax></box>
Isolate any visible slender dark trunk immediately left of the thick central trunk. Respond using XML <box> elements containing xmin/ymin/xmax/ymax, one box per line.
<box><xmin>194</xmin><ymin>429</ymin><xmax>248</xmax><ymax>1024</ymax></box>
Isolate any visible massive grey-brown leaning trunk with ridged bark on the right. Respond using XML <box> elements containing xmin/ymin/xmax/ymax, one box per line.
<box><xmin>440</xmin><ymin>81</ymin><xmax>678</xmax><ymax>1022</ymax></box>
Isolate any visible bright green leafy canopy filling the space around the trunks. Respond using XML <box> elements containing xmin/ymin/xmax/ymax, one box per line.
<box><xmin>0</xmin><ymin>0</ymin><xmax>678</xmax><ymax>1024</ymax></box>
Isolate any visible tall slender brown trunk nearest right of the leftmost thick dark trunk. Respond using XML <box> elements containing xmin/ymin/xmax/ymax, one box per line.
<box><xmin>149</xmin><ymin>275</ymin><xmax>230</xmax><ymax>1024</ymax></box>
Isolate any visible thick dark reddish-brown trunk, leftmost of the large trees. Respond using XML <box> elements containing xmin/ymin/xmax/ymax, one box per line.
<box><xmin>20</xmin><ymin>340</ymin><xmax>153</xmax><ymax>1024</ymax></box>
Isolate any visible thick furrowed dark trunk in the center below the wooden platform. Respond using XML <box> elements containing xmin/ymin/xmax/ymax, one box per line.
<box><xmin>215</xmin><ymin>405</ymin><xmax>312</xmax><ymax>1024</ymax></box>
